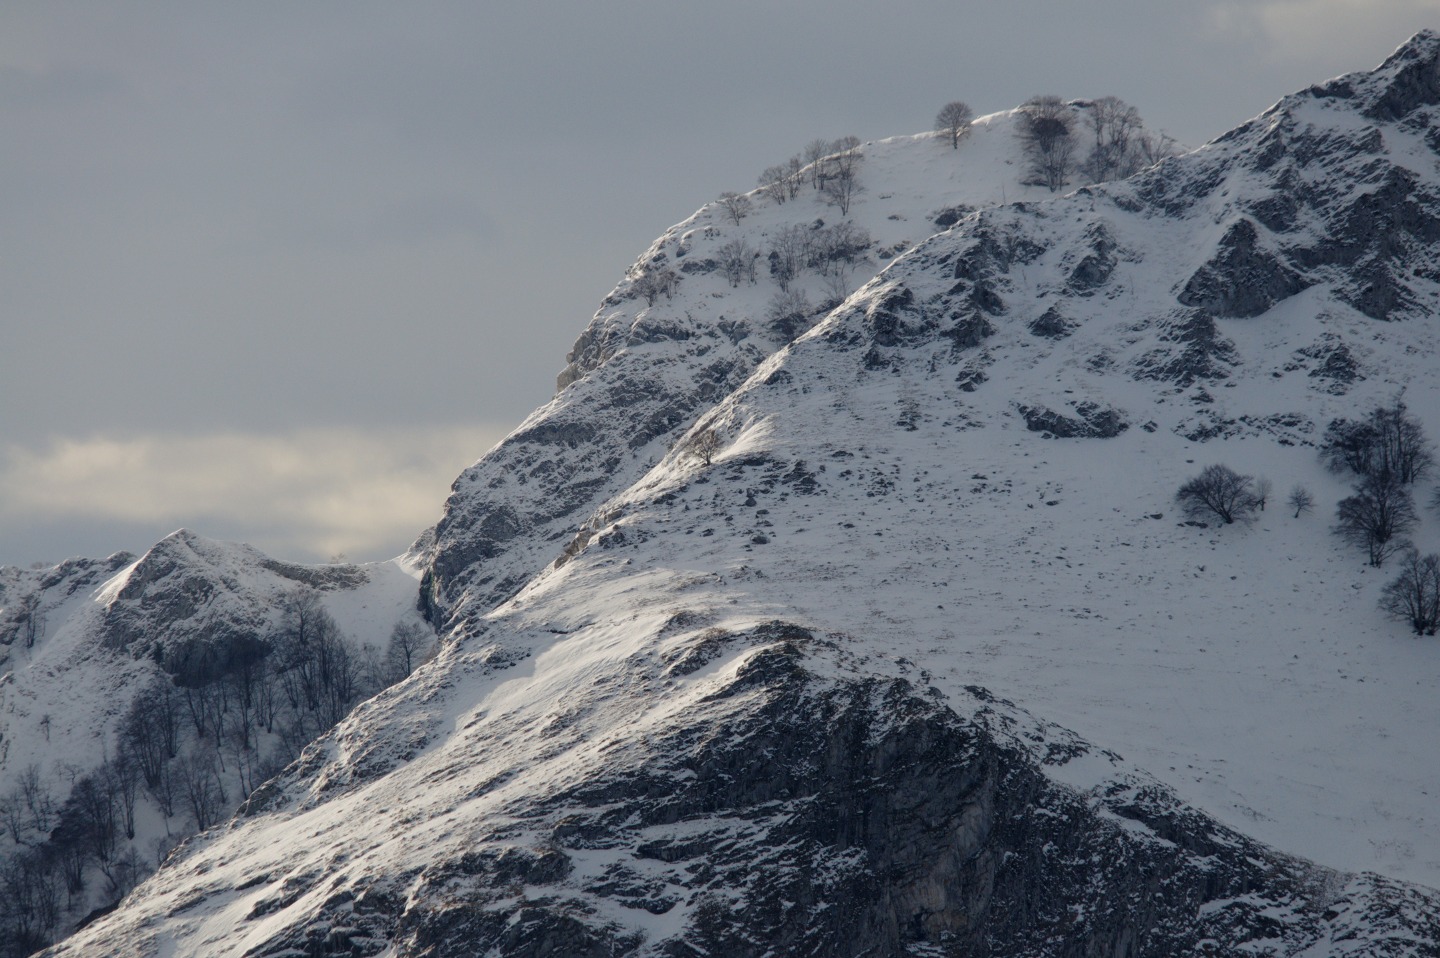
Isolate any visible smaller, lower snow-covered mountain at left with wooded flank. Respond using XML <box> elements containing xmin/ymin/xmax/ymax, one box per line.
<box><xmin>0</xmin><ymin>530</ymin><xmax>433</xmax><ymax>955</ymax></box>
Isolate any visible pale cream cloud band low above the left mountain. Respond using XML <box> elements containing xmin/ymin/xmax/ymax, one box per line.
<box><xmin>0</xmin><ymin>425</ymin><xmax>507</xmax><ymax>559</ymax></box>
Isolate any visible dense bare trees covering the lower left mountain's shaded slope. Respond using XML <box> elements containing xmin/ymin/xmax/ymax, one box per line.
<box><xmin>0</xmin><ymin>589</ymin><xmax>433</xmax><ymax>958</ymax></box>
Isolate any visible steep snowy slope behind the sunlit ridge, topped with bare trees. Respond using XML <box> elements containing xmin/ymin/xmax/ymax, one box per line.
<box><xmin>412</xmin><ymin>102</ymin><xmax>1169</xmax><ymax>625</ymax></box>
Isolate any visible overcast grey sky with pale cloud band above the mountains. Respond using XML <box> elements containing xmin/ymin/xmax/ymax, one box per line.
<box><xmin>0</xmin><ymin>0</ymin><xmax>1440</xmax><ymax>565</ymax></box>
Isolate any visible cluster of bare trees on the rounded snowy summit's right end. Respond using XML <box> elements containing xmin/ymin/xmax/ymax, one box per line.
<box><xmin>1020</xmin><ymin>95</ymin><xmax>1175</xmax><ymax>193</ymax></box>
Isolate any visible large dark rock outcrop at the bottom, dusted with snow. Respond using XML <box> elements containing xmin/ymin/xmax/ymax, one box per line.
<box><xmin>208</xmin><ymin>622</ymin><xmax>1437</xmax><ymax>958</ymax></box>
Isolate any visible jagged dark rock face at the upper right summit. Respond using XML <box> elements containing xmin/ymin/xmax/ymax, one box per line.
<box><xmin>1138</xmin><ymin>33</ymin><xmax>1440</xmax><ymax>320</ymax></box>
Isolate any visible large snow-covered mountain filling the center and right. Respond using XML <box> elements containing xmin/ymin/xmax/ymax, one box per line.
<box><xmin>7</xmin><ymin>33</ymin><xmax>1440</xmax><ymax>958</ymax></box>
